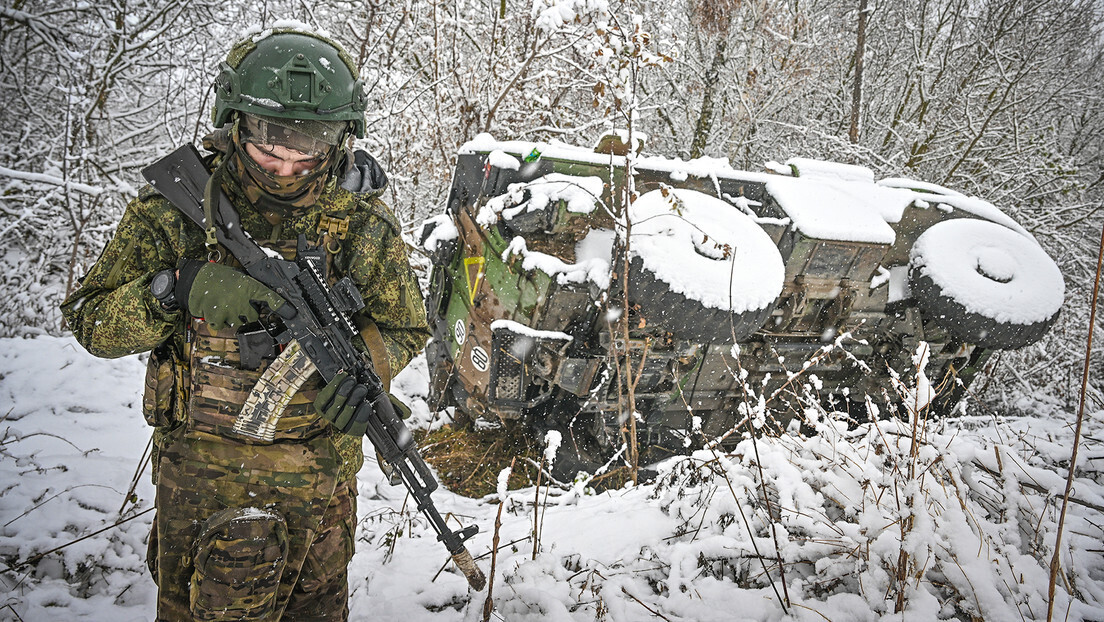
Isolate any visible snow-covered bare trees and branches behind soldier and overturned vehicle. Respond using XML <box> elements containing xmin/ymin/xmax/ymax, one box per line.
<box><xmin>0</xmin><ymin>0</ymin><xmax>1104</xmax><ymax>408</ymax></box>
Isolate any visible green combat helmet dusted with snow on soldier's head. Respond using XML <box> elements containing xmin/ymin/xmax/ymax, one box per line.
<box><xmin>213</xmin><ymin>29</ymin><xmax>367</xmax><ymax>138</ymax></box>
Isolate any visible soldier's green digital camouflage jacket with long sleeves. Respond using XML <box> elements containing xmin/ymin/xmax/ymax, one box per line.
<box><xmin>62</xmin><ymin>146</ymin><xmax>428</xmax><ymax>476</ymax></box>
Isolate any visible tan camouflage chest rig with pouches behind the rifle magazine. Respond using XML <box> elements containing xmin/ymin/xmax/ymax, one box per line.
<box><xmin>188</xmin><ymin>232</ymin><xmax>339</xmax><ymax>444</ymax></box>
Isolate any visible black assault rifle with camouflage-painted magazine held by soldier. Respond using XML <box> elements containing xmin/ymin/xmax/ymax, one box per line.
<box><xmin>142</xmin><ymin>145</ymin><xmax>486</xmax><ymax>590</ymax></box>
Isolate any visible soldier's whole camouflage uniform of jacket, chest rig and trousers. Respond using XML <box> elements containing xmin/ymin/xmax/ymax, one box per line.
<box><xmin>62</xmin><ymin>143</ymin><xmax>428</xmax><ymax>620</ymax></box>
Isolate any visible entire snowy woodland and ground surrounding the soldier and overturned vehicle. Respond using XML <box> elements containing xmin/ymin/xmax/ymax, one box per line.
<box><xmin>0</xmin><ymin>0</ymin><xmax>1104</xmax><ymax>620</ymax></box>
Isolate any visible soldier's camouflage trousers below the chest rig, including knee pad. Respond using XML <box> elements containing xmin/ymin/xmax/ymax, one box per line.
<box><xmin>148</xmin><ymin>430</ymin><xmax>357</xmax><ymax>622</ymax></box>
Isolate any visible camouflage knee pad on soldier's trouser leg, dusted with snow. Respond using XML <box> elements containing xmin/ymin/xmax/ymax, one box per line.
<box><xmin>190</xmin><ymin>507</ymin><xmax>288</xmax><ymax>621</ymax></box>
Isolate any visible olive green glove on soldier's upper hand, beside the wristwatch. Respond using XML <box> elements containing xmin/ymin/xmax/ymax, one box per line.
<box><xmin>176</xmin><ymin>261</ymin><xmax>295</xmax><ymax>330</ymax></box>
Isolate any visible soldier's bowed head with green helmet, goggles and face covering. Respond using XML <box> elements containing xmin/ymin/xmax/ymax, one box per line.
<box><xmin>204</xmin><ymin>28</ymin><xmax>367</xmax><ymax>215</ymax></box>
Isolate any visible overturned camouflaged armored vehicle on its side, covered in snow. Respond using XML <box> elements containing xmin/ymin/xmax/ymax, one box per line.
<box><xmin>422</xmin><ymin>135</ymin><xmax>1063</xmax><ymax>479</ymax></box>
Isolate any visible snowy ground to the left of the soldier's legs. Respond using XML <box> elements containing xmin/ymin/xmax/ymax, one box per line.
<box><xmin>0</xmin><ymin>337</ymin><xmax>155</xmax><ymax>620</ymax></box>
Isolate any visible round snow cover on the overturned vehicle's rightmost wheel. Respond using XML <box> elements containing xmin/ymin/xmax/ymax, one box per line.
<box><xmin>910</xmin><ymin>219</ymin><xmax>1065</xmax><ymax>324</ymax></box>
